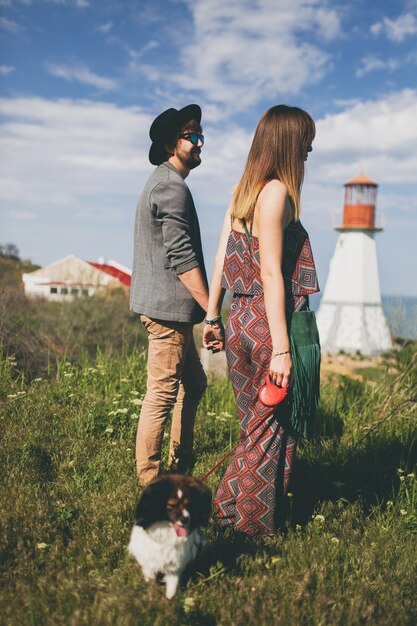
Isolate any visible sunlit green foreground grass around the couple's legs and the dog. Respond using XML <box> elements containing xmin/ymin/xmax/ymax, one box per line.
<box><xmin>0</xmin><ymin>344</ymin><xmax>417</xmax><ymax>626</ymax></box>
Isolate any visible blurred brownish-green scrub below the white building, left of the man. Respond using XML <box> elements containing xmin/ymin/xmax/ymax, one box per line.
<box><xmin>0</xmin><ymin>286</ymin><xmax>146</xmax><ymax>380</ymax></box>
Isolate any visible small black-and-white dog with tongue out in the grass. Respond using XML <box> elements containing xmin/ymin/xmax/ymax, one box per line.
<box><xmin>128</xmin><ymin>474</ymin><xmax>211</xmax><ymax>599</ymax></box>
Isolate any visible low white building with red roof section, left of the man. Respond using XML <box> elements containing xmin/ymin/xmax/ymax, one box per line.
<box><xmin>22</xmin><ymin>254</ymin><xmax>131</xmax><ymax>302</ymax></box>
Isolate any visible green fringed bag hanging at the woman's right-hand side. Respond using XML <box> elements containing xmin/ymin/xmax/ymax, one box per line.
<box><xmin>289</xmin><ymin>310</ymin><xmax>321</xmax><ymax>436</ymax></box>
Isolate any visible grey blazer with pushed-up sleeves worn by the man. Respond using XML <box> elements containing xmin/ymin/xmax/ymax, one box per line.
<box><xmin>130</xmin><ymin>161</ymin><xmax>207</xmax><ymax>323</ymax></box>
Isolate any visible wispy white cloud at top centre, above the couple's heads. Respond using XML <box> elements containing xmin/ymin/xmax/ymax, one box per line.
<box><xmin>136</xmin><ymin>0</ymin><xmax>340</xmax><ymax>116</ymax></box>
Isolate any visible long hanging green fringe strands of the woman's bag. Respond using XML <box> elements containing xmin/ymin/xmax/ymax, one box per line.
<box><xmin>290</xmin><ymin>333</ymin><xmax>320</xmax><ymax>436</ymax></box>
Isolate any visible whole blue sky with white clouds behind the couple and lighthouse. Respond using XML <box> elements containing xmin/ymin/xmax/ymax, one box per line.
<box><xmin>0</xmin><ymin>0</ymin><xmax>417</xmax><ymax>296</ymax></box>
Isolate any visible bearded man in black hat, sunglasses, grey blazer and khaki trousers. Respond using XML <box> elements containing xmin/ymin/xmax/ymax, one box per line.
<box><xmin>130</xmin><ymin>104</ymin><xmax>208</xmax><ymax>486</ymax></box>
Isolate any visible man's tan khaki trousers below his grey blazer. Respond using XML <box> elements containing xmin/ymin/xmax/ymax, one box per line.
<box><xmin>136</xmin><ymin>315</ymin><xmax>207</xmax><ymax>485</ymax></box>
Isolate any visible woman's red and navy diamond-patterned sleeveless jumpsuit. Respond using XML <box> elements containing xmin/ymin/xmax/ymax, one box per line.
<box><xmin>213</xmin><ymin>221</ymin><xmax>319</xmax><ymax>537</ymax></box>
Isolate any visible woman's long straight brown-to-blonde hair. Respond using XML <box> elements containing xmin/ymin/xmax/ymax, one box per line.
<box><xmin>230</xmin><ymin>104</ymin><xmax>316</xmax><ymax>220</ymax></box>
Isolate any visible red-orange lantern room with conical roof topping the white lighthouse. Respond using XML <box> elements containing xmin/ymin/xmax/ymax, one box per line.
<box><xmin>337</xmin><ymin>172</ymin><xmax>381</xmax><ymax>231</ymax></box>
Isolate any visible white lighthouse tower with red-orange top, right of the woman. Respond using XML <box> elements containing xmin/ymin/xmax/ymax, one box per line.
<box><xmin>317</xmin><ymin>173</ymin><xmax>392</xmax><ymax>356</ymax></box>
